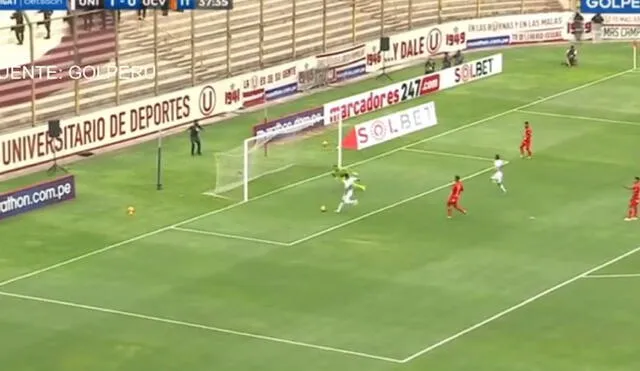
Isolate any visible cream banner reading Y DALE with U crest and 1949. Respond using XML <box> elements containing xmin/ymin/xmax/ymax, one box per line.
<box><xmin>366</xmin><ymin>22</ymin><xmax>467</xmax><ymax>72</ymax></box>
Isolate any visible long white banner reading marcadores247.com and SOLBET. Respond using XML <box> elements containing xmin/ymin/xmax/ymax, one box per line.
<box><xmin>324</xmin><ymin>54</ymin><xmax>502</xmax><ymax>125</ymax></box>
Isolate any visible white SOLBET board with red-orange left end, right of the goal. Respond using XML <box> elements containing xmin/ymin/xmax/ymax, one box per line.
<box><xmin>342</xmin><ymin>102</ymin><xmax>438</xmax><ymax>151</ymax></box>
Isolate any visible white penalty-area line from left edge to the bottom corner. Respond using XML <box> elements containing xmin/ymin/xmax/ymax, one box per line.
<box><xmin>0</xmin><ymin>291</ymin><xmax>401</xmax><ymax>363</ymax></box>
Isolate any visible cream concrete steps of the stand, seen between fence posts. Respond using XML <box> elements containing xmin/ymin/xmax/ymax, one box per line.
<box><xmin>0</xmin><ymin>0</ymin><xmax>557</xmax><ymax>130</ymax></box>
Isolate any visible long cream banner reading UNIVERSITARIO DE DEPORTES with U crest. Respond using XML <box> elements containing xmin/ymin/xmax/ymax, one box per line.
<box><xmin>0</xmin><ymin>78</ymin><xmax>242</xmax><ymax>174</ymax></box>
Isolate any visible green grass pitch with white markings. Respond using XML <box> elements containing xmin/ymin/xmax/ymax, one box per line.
<box><xmin>0</xmin><ymin>44</ymin><xmax>640</xmax><ymax>371</ymax></box>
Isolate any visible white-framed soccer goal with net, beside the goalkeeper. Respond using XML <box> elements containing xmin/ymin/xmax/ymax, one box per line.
<box><xmin>205</xmin><ymin>120</ymin><xmax>342</xmax><ymax>201</ymax></box>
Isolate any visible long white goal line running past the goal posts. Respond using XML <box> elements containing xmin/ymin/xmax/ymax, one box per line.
<box><xmin>0</xmin><ymin>70</ymin><xmax>631</xmax><ymax>287</ymax></box>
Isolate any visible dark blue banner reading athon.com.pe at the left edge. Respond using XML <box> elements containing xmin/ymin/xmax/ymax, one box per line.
<box><xmin>0</xmin><ymin>175</ymin><xmax>76</xmax><ymax>220</ymax></box>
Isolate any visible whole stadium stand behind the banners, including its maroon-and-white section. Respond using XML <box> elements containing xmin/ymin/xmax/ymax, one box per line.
<box><xmin>0</xmin><ymin>0</ymin><xmax>561</xmax><ymax>131</ymax></box>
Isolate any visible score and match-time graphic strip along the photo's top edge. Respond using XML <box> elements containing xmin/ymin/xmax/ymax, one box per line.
<box><xmin>0</xmin><ymin>0</ymin><xmax>233</xmax><ymax>11</ymax></box>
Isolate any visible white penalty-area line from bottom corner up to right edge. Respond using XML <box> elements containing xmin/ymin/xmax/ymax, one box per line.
<box><xmin>402</xmin><ymin>247</ymin><xmax>640</xmax><ymax>363</ymax></box>
